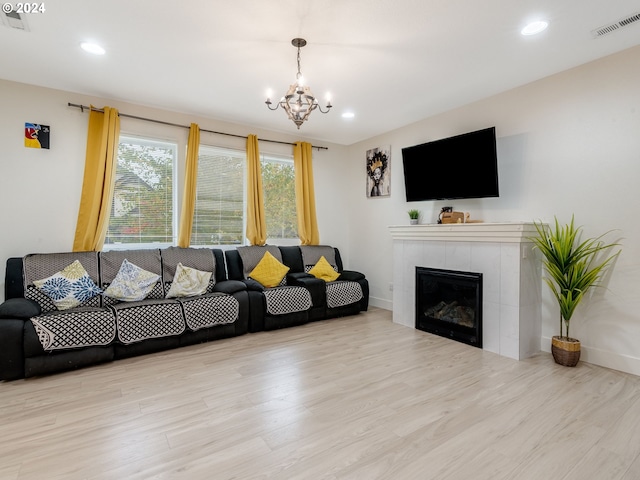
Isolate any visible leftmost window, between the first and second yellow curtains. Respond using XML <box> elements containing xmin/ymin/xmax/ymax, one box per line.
<box><xmin>105</xmin><ymin>136</ymin><xmax>178</xmax><ymax>248</ymax></box>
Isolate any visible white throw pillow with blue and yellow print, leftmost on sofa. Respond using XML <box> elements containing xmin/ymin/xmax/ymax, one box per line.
<box><xmin>33</xmin><ymin>260</ymin><xmax>102</xmax><ymax>310</ymax></box>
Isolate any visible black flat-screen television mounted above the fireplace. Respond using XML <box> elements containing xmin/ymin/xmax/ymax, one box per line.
<box><xmin>402</xmin><ymin>127</ymin><xmax>498</xmax><ymax>202</ymax></box>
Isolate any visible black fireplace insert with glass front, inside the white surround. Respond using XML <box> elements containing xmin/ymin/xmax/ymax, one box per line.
<box><xmin>416</xmin><ymin>267</ymin><xmax>482</xmax><ymax>348</ymax></box>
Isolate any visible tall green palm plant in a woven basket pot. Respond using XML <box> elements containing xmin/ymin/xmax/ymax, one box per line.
<box><xmin>531</xmin><ymin>216</ymin><xmax>620</xmax><ymax>367</ymax></box>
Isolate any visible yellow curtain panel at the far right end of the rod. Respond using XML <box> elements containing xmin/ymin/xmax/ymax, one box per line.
<box><xmin>293</xmin><ymin>142</ymin><xmax>320</xmax><ymax>245</ymax></box>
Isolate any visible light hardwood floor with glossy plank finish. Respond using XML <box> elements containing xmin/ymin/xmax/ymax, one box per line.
<box><xmin>0</xmin><ymin>308</ymin><xmax>640</xmax><ymax>480</ymax></box>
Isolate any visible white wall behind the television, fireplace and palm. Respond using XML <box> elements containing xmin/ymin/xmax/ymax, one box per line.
<box><xmin>348</xmin><ymin>47</ymin><xmax>640</xmax><ymax>374</ymax></box>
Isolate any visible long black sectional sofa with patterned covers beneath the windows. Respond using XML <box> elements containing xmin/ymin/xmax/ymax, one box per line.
<box><xmin>0</xmin><ymin>246</ymin><xmax>369</xmax><ymax>380</ymax></box>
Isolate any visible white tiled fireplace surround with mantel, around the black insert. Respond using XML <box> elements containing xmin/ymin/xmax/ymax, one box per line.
<box><xmin>389</xmin><ymin>223</ymin><xmax>542</xmax><ymax>360</ymax></box>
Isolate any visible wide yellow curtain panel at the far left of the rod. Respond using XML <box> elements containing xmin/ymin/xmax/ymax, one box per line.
<box><xmin>73</xmin><ymin>106</ymin><xmax>120</xmax><ymax>252</ymax></box>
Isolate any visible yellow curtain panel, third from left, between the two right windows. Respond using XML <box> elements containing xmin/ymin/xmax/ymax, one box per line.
<box><xmin>247</xmin><ymin>135</ymin><xmax>267</xmax><ymax>245</ymax></box>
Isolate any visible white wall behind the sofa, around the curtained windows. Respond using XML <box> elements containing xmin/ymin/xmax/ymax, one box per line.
<box><xmin>0</xmin><ymin>80</ymin><xmax>349</xmax><ymax>301</ymax></box>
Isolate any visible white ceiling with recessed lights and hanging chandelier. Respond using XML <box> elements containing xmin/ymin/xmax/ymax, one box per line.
<box><xmin>0</xmin><ymin>0</ymin><xmax>640</xmax><ymax>145</ymax></box>
